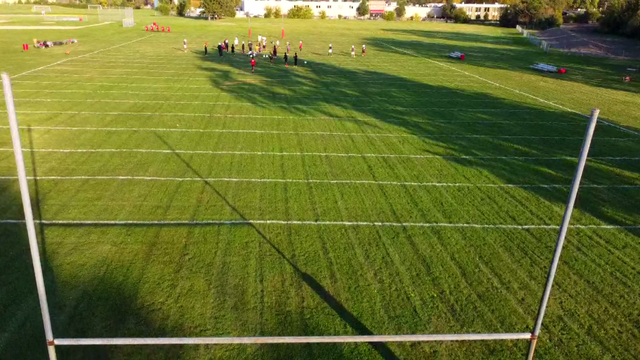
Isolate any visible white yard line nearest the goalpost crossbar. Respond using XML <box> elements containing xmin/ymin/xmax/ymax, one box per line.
<box><xmin>0</xmin><ymin>219</ymin><xmax>640</xmax><ymax>230</ymax></box>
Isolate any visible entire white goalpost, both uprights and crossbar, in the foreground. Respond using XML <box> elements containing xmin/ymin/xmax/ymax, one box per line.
<box><xmin>2</xmin><ymin>68</ymin><xmax>600</xmax><ymax>360</ymax></box>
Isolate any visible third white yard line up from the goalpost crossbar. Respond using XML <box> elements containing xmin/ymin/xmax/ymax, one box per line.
<box><xmin>0</xmin><ymin>148</ymin><xmax>640</xmax><ymax>161</ymax></box>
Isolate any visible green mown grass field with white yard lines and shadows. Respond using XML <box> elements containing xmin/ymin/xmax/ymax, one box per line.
<box><xmin>0</xmin><ymin>7</ymin><xmax>640</xmax><ymax>359</ymax></box>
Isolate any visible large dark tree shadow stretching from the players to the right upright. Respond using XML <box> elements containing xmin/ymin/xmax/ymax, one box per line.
<box><xmin>194</xmin><ymin>50</ymin><xmax>640</xmax><ymax>356</ymax></box>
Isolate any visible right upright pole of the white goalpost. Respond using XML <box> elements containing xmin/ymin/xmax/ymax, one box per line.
<box><xmin>527</xmin><ymin>108</ymin><xmax>600</xmax><ymax>360</ymax></box>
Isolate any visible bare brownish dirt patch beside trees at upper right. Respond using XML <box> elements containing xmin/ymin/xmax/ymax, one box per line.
<box><xmin>536</xmin><ymin>24</ymin><xmax>640</xmax><ymax>59</ymax></box>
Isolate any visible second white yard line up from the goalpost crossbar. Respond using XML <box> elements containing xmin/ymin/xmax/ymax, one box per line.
<box><xmin>0</xmin><ymin>176</ymin><xmax>640</xmax><ymax>189</ymax></box>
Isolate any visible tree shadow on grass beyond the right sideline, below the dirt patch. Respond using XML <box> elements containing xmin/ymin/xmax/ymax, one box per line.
<box><xmin>380</xmin><ymin>29</ymin><xmax>640</xmax><ymax>94</ymax></box>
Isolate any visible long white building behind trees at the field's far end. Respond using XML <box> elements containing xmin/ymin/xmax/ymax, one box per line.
<box><xmin>242</xmin><ymin>0</ymin><xmax>506</xmax><ymax>20</ymax></box>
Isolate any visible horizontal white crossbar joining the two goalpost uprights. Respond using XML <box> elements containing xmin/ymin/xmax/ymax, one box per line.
<box><xmin>55</xmin><ymin>333</ymin><xmax>531</xmax><ymax>345</ymax></box>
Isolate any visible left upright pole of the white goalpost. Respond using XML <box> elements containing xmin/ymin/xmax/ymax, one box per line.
<box><xmin>2</xmin><ymin>73</ymin><xmax>56</xmax><ymax>360</ymax></box>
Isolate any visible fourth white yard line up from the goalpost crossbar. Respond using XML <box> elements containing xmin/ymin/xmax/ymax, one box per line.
<box><xmin>0</xmin><ymin>124</ymin><xmax>633</xmax><ymax>141</ymax></box>
